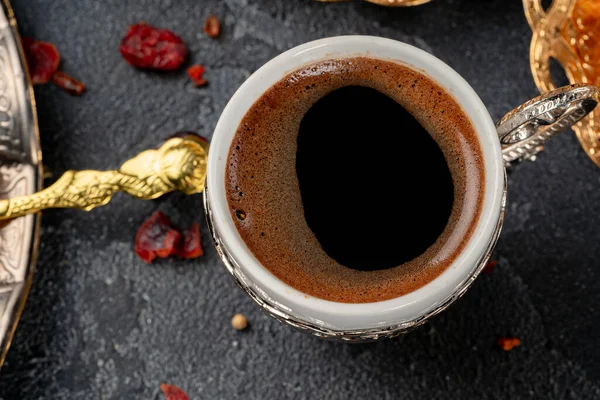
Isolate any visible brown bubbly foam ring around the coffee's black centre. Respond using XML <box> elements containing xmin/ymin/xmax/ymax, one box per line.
<box><xmin>225</xmin><ymin>57</ymin><xmax>485</xmax><ymax>303</ymax></box>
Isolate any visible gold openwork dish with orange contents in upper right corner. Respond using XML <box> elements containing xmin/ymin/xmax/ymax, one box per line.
<box><xmin>523</xmin><ymin>0</ymin><xmax>600</xmax><ymax>166</ymax></box>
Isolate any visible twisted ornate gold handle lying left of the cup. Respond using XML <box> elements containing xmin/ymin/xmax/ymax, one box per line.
<box><xmin>0</xmin><ymin>134</ymin><xmax>208</xmax><ymax>220</ymax></box>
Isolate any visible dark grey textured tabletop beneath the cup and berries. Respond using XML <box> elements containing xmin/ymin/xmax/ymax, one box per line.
<box><xmin>0</xmin><ymin>0</ymin><xmax>600</xmax><ymax>400</ymax></box>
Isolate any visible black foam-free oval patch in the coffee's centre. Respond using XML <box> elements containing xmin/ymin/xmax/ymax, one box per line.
<box><xmin>296</xmin><ymin>86</ymin><xmax>454</xmax><ymax>271</ymax></box>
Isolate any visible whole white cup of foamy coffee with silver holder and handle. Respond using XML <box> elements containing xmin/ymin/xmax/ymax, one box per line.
<box><xmin>204</xmin><ymin>36</ymin><xmax>598</xmax><ymax>340</ymax></box>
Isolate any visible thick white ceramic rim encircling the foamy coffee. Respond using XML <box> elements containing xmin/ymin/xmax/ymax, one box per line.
<box><xmin>205</xmin><ymin>36</ymin><xmax>506</xmax><ymax>331</ymax></box>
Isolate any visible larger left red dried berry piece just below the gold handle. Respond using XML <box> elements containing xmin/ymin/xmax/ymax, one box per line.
<box><xmin>135</xmin><ymin>211</ymin><xmax>181</xmax><ymax>264</ymax></box>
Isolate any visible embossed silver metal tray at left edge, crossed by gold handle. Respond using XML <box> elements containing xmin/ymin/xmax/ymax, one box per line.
<box><xmin>0</xmin><ymin>2</ymin><xmax>42</xmax><ymax>365</ymax></box>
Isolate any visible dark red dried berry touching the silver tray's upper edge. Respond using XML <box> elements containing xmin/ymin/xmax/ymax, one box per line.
<box><xmin>22</xmin><ymin>38</ymin><xmax>60</xmax><ymax>85</ymax></box>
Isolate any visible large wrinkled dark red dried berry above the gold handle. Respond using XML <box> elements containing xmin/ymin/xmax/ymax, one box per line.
<box><xmin>119</xmin><ymin>23</ymin><xmax>188</xmax><ymax>71</ymax></box>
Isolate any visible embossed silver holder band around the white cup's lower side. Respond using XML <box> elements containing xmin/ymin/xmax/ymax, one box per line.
<box><xmin>204</xmin><ymin>180</ymin><xmax>507</xmax><ymax>342</ymax></box>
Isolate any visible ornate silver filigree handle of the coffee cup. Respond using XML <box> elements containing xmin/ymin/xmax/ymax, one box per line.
<box><xmin>496</xmin><ymin>84</ymin><xmax>600</xmax><ymax>166</ymax></box>
